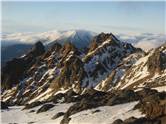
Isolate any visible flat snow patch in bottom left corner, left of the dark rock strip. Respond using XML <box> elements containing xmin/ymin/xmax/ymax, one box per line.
<box><xmin>1</xmin><ymin>104</ymin><xmax>72</xmax><ymax>124</ymax></box>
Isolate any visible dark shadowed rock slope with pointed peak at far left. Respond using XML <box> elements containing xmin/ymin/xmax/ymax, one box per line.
<box><xmin>2</xmin><ymin>42</ymin><xmax>45</xmax><ymax>89</ymax></box>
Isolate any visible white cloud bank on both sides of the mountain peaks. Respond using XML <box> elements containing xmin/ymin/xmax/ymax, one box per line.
<box><xmin>2</xmin><ymin>30</ymin><xmax>166</xmax><ymax>51</ymax></box>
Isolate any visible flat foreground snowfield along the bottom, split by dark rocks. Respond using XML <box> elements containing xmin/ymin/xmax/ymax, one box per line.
<box><xmin>1</xmin><ymin>102</ymin><xmax>144</xmax><ymax>124</ymax></box>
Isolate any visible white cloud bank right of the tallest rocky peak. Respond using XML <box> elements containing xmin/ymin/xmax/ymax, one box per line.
<box><xmin>116</xmin><ymin>33</ymin><xmax>166</xmax><ymax>51</ymax></box>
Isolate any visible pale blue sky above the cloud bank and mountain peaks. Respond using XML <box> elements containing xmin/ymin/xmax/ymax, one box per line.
<box><xmin>2</xmin><ymin>1</ymin><xmax>166</xmax><ymax>33</ymax></box>
